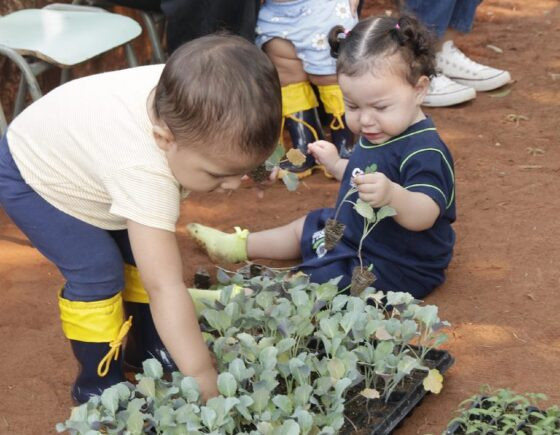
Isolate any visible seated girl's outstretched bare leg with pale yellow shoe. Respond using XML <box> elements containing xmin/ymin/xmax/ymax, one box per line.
<box><xmin>187</xmin><ymin>216</ymin><xmax>305</xmax><ymax>263</ymax></box>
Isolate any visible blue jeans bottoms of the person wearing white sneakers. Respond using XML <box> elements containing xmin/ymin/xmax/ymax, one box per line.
<box><xmin>405</xmin><ymin>0</ymin><xmax>482</xmax><ymax>38</ymax></box>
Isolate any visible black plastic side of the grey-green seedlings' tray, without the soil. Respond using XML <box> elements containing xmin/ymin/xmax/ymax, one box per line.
<box><xmin>341</xmin><ymin>349</ymin><xmax>455</xmax><ymax>435</ymax></box>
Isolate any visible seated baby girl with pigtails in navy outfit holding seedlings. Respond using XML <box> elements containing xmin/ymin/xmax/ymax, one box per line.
<box><xmin>188</xmin><ymin>16</ymin><xmax>455</xmax><ymax>298</ymax></box>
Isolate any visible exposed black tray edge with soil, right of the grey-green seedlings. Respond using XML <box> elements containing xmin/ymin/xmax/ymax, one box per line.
<box><xmin>341</xmin><ymin>349</ymin><xmax>455</xmax><ymax>435</ymax></box>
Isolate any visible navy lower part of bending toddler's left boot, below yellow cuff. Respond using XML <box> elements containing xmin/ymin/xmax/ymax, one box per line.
<box><xmin>70</xmin><ymin>340</ymin><xmax>125</xmax><ymax>403</ymax></box>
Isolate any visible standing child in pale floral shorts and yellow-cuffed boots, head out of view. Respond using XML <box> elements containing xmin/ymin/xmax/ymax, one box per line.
<box><xmin>256</xmin><ymin>0</ymin><xmax>358</xmax><ymax>178</ymax></box>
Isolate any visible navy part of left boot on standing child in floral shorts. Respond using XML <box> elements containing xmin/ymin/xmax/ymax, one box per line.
<box><xmin>280</xmin><ymin>108</ymin><xmax>324</xmax><ymax>178</ymax></box>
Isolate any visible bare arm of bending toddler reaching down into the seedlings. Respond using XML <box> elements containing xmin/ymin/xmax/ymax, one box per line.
<box><xmin>128</xmin><ymin>221</ymin><xmax>218</xmax><ymax>400</ymax></box>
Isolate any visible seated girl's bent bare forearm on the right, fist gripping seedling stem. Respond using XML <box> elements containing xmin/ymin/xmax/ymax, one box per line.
<box><xmin>354</xmin><ymin>172</ymin><xmax>439</xmax><ymax>231</ymax></box>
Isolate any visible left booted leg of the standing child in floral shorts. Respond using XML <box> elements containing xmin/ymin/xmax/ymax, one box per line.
<box><xmin>263</xmin><ymin>38</ymin><xmax>323</xmax><ymax>178</ymax></box>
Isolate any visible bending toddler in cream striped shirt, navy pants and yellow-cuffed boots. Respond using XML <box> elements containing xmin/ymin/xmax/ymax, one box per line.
<box><xmin>0</xmin><ymin>35</ymin><xmax>282</xmax><ymax>402</ymax></box>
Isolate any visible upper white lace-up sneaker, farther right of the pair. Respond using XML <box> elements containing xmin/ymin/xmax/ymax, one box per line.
<box><xmin>436</xmin><ymin>41</ymin><xmax>511</xmax><ymax>91</ymax></box>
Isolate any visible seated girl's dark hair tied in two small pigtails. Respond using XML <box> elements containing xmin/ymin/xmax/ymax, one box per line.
<box><xmin>329</xmin><ymin>15</ymin><xmax>436</xmax><ymax>86</ymax></box>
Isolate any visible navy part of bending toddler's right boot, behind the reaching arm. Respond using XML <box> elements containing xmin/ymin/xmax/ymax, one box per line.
<box><xmin>123</xmin><ymin>301</ymin><xmax>178</xmax><ymax>373</ymax></box>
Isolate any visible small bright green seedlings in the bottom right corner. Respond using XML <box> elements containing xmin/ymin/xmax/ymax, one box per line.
<box><xmin>446</xmin><ymin>386</ymin><xmax>560</xmax><ymax>435</ymax></box>
